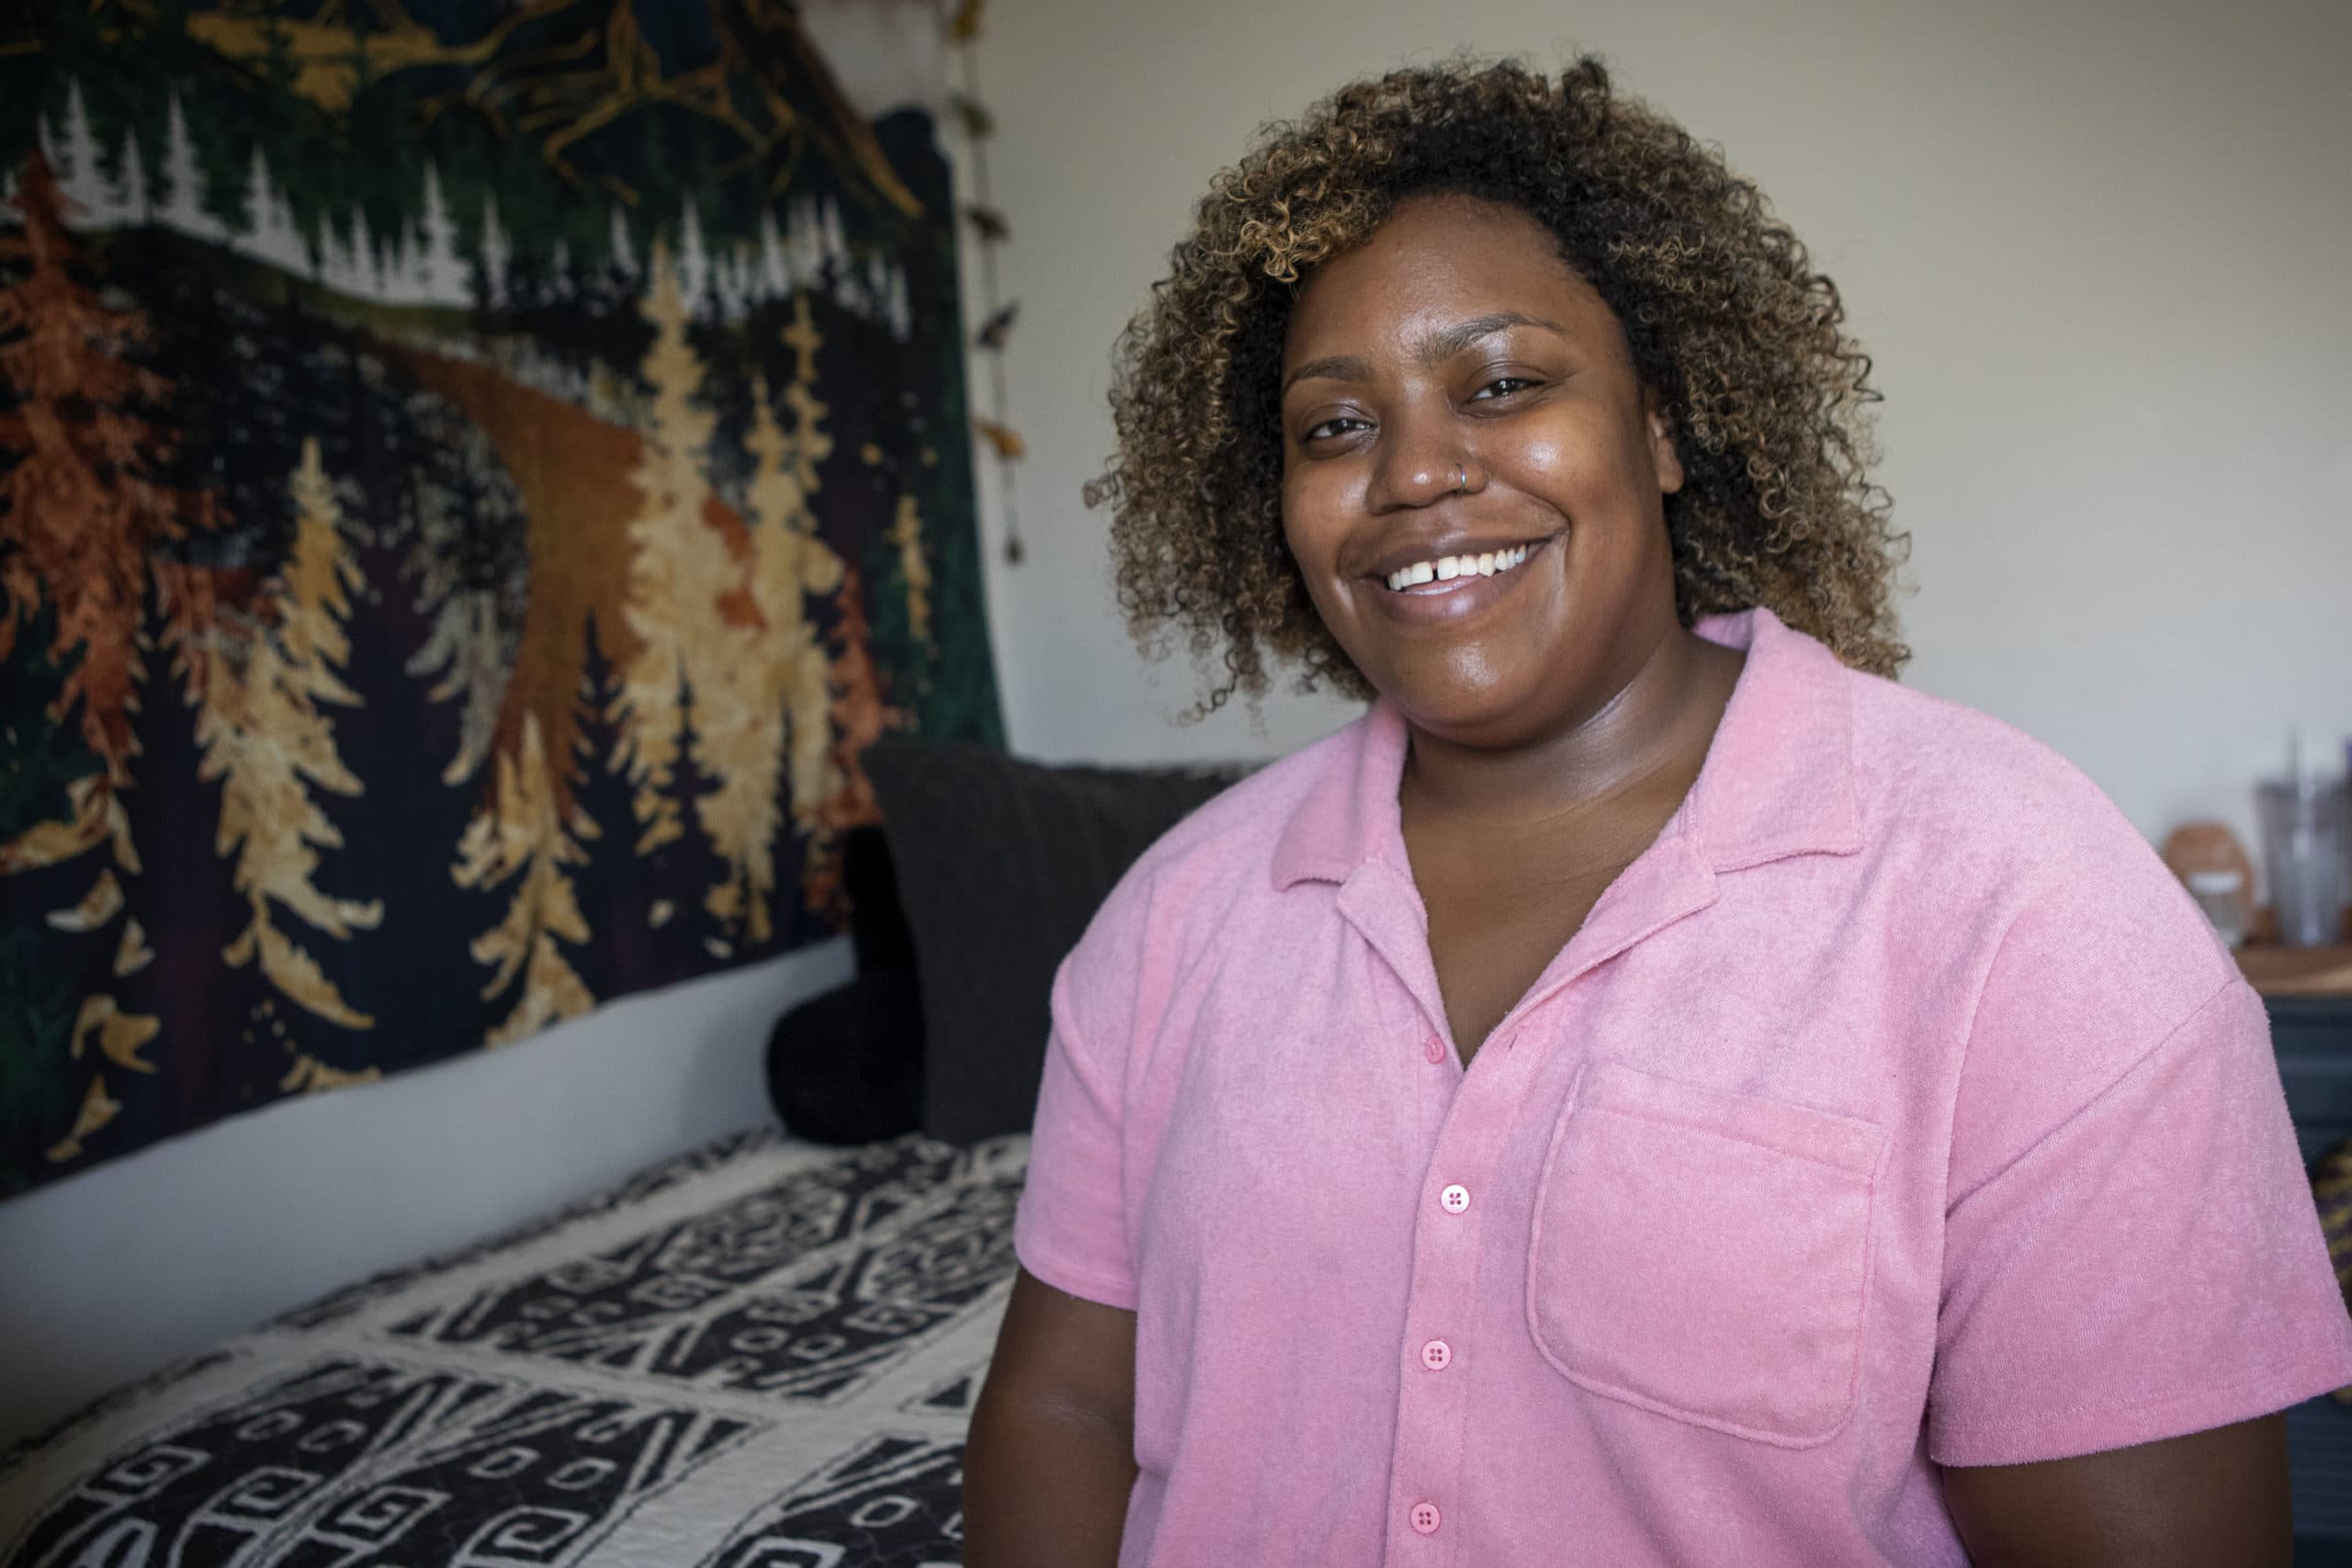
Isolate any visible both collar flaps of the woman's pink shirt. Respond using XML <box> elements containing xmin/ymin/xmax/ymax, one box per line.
<box><xmin>1272</xmin><ymin>609</ymin><xmax>1863</xmax><ymax>888</ymax></box>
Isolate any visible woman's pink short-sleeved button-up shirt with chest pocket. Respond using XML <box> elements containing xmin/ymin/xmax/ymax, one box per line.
<box><xmin>1016</xmin><ymin>611</ymin><xmax>2352</xmax><ymax>1568</ymax></box>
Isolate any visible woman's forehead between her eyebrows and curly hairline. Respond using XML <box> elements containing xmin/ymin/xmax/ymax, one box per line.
<box><xmin>1284</xmin><ymin>195</ymin><xmax>1623</xmax><ymax>362</ymax></box>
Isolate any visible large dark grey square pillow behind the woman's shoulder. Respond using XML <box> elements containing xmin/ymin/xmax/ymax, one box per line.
<box><xmin>864</xmin><ymin>740</ymin><xmax>1238</xmax><ymax>1143</ymax></box>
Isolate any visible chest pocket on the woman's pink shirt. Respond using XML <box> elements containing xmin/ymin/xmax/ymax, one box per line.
<box><xmin>1526</xmin><ymin>1063</ymin><xmax>1886</xmax><ymax>1448</ymax></box>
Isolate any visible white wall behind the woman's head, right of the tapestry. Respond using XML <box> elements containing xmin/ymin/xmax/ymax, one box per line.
<box><xmin>959</xmin><ymin>0</ymin><xmax>2352</xmax><ymax>860</ymax></box>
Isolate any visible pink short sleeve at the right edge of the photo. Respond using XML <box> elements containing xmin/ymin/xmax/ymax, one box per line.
<box><xmin>1928</xmin><ymin>915</ymin><xmax>2352</xmax><ymax>1464</ymax></box>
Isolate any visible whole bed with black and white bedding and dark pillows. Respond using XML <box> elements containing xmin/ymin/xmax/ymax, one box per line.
<box><xmin>0</xmin><ymin>740</ymin><xmax>1235</xmax><ymax>1568</ymax></box>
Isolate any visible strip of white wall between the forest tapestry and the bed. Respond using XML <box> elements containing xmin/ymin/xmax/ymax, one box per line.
<box><xmin>0</xmin><ymin>941</ymin><xmax>849</xmax><ymax>1446</ymax></box>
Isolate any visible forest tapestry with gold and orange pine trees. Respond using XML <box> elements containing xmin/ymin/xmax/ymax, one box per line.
<box><xmin>0</xmin><ymin>0</ymin><xmax>1000</xmax><ymax>1194</ymax></box>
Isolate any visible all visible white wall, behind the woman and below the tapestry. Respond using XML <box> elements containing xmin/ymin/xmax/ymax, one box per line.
<box><xmin>18</xmin><ymin>0</ymin><xmax>2352</xmax><ymax>1441</ymax></box>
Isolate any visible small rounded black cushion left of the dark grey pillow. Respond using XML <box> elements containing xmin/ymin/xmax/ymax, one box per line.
<box><xmin>767</xmin><ymin>968</ymin><xmax>922</xmax><ymax>1143</ymax></box>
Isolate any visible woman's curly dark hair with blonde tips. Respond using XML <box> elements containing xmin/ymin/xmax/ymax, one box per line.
<box><xmin>1087</xmin><ymin>56</ymin><xmax>1910</xmax><ymax>710</ymax></box>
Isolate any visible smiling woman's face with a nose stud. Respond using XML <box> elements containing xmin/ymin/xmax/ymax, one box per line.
<box><xmin>1282</xmin><ymin>197</ymin><xmax>1681</xmax><ymax>748</ymax></box>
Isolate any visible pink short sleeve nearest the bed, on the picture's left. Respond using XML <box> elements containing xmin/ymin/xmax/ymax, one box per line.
<box><xmin>1013</xmin><ymin>921</ymin><xmax>1136</xmax><ymax>1312</ymax></box>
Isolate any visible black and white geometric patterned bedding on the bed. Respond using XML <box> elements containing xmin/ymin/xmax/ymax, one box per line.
<box><xmin>0</xmin><ymin>1128</ymin><xmax>1028</xmax><ymax>1568</ymax></box>
